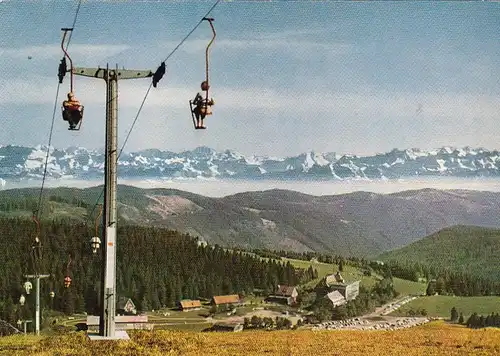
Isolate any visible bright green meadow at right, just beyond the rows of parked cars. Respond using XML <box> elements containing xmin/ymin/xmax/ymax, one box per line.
<box><xmin>390</xmin><ymin>295</ymin><xmax>500</xmax><ymax>318</ymax></box>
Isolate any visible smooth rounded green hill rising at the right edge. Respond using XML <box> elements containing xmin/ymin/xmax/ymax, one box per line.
<box><xmin>379</xmin><ymin>226</ymin><xmax>500</xmax><ymax>280</ymax></box>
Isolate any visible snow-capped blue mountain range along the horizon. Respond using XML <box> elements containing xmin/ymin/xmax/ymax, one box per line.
<box><xmin>0</xmin><ymin>145</ymin><xmax>500</xmax><ymax>180</ymax></box>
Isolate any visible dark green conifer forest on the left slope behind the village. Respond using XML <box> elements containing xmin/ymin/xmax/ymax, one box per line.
<box><xmin>0</xmin><ymin>219</ymin><xmax>315</xmax><ymax>319</ymax></box>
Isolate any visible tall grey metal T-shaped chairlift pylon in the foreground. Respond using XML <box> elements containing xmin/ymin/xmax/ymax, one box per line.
<box><xmin>73</xmin><ymin>65</ymin><xmax>153</xmax><ymax>340</ymax></box>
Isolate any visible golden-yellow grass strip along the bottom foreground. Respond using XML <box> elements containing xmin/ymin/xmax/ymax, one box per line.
<box><xmin>0</xmin><ymin>321</ymin><xmax>500</xmax><ymax>356</ymax></box>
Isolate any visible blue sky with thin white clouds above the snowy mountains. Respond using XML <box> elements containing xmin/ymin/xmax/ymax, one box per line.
<box><xmin>0</xmin><ymin>0</ymin><xmax>500</xmax><ymax>156</ymax></box>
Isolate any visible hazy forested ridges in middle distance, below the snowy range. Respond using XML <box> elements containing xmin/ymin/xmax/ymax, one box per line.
<box><xmin>0</xmin><ymin>185</ymin><xmax>500</xmax><ymax>258</ymax></box>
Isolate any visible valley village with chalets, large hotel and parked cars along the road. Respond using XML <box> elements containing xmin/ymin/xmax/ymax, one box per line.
<box><xmin>80</xmin><ymin>272</ymin><xmax>429</xmax><ymax>332</ymax></box>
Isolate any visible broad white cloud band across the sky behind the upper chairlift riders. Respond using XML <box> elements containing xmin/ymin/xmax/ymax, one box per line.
<box><xmin>0</xmin><ymin>77</ymin><xmax>500</xmax><ymax>121</ymax></box>
